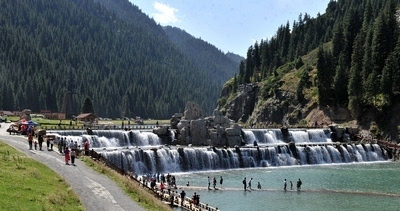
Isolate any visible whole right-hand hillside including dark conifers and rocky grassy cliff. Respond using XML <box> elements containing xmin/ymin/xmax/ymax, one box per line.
<box><xmin>219</xmin><ymin>0</ymin><xmax>400</xmax><ymax>137</ymax></box>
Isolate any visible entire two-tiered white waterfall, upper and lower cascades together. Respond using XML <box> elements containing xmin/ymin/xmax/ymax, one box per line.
<box><xmin>47</xmin><ymin>129</ymin><xmax>388</xmax><ymax>174</ymax></box>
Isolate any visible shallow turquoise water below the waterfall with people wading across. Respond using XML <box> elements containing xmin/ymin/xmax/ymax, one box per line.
<box><xmin>175</xmin><ymin>162</ymin><xmax>400</xmax><ymax>210</ymax></box>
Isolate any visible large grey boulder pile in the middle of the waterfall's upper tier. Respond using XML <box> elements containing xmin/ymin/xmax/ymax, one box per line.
<box><xmin>174</xmin><ymin>102</ymin><xmax>243</xmax><ymax>147</ymax></box>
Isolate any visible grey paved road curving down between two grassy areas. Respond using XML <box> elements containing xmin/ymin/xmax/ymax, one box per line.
<box><xmin>0</xmin><ymin>123</ymin><xmax>145</xmax><ymax>211</ymax></box>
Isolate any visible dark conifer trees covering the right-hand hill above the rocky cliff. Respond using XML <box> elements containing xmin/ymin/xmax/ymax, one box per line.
<box><xmin>228</xmin><ymin>0</ymin><xmax>400</xmax><ymax>118</ymax></box>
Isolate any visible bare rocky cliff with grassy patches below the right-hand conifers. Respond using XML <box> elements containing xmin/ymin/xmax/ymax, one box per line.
<box><xmin>218</xmin><ymin>62</ymin><xmax>352</xmax><ymax>127</ymax></box>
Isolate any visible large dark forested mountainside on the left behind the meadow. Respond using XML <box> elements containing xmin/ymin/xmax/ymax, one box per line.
<box><xmin>0</xmin><ymin>0</ymin><xmax>220</xmax><ymax>118</ymax></box>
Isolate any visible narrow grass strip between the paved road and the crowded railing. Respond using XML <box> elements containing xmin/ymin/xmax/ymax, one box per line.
<box><xmin>81</xmin><ymin>157</ymin><xmax>172</xmax><ymax>210</ymax></box>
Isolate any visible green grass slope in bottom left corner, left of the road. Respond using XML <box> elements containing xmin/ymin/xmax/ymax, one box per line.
<box><xmin>0</xmin><ymin>141</ymin><xmax>85</xmax><ymax>210</ymax></box>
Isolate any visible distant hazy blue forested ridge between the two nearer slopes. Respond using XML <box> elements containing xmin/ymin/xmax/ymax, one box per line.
<box><xmin>164</xmin><ymin>26</ymin><xmax>244</xmax><ymax>86</ymax></box>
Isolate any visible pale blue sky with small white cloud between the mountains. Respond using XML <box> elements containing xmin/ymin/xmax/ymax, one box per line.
<box><xmin>129</xmin><ymin>0</ymin><xmax>330</xmax><ymax>57</ymax></box>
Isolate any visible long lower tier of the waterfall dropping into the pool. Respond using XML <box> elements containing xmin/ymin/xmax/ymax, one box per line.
<box><xmin>100</xmin><ymin>144</ymin><xmax>387</xmax><ymax>174</ymax></box>
